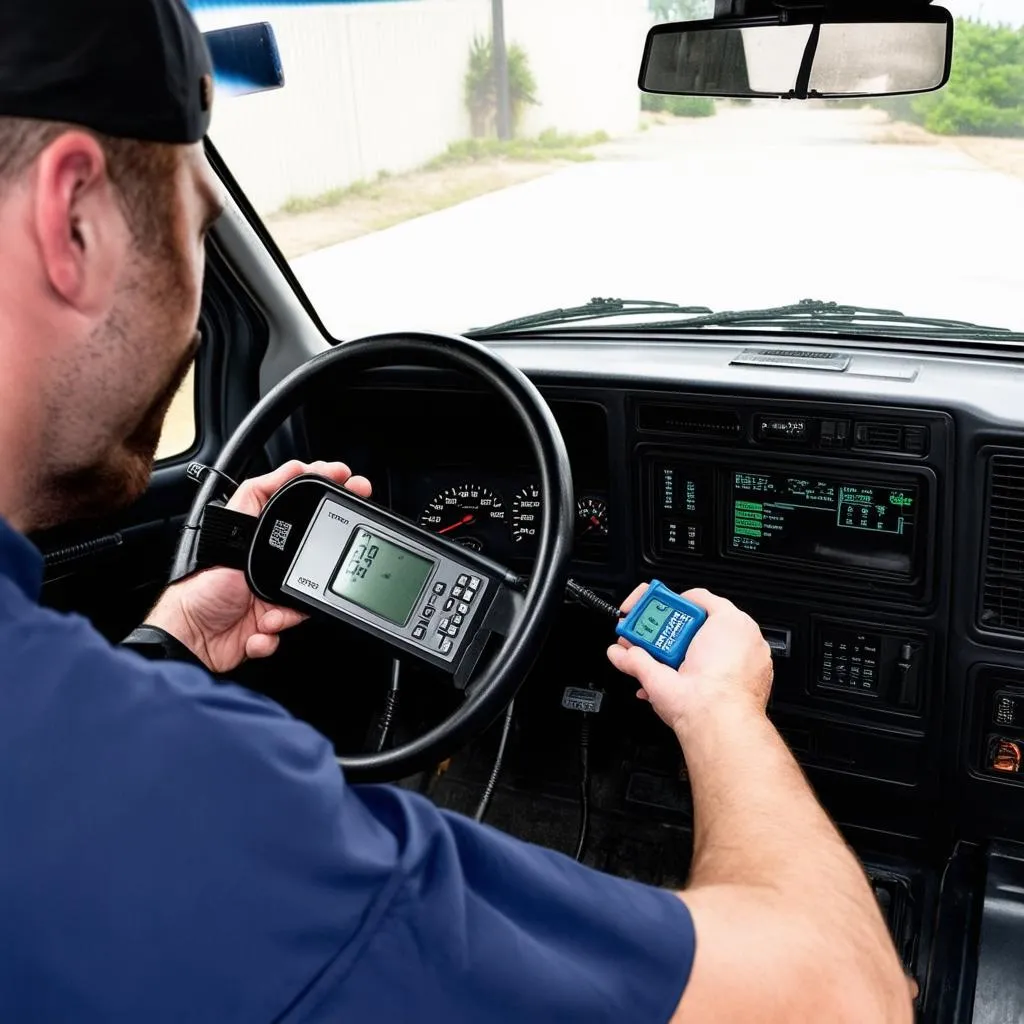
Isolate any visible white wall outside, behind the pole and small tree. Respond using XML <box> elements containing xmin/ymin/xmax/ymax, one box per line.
<box><xmin>197</xmin><ymin>0</ymin><xmax>649</xmax><ymax>213</ymax></box>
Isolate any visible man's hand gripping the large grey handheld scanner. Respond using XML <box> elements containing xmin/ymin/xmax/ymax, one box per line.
<box><xmin>146</xmin><ymin>462</ymin><xmax>371</xmax><ymax>672</ymax></box>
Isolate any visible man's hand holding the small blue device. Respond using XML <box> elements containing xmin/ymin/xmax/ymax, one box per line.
<box><xmin>608</xmin><ymin>584</ymin><xmax>772</xmax><ymax>734</ymax></box>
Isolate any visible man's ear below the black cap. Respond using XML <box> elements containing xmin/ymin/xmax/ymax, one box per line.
<box><xmin>34</xmin><ymin>130</ymin><xmax>129</xmax><ymax>316</ymax></box>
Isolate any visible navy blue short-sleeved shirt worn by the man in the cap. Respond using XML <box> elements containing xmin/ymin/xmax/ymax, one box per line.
<box><xmin>0</xmin><ymin>521</ymin><xmax>694</xmax><ymax>1024</ymax></box>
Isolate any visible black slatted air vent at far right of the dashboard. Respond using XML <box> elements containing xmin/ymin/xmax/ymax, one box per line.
<box><xmin>981</xmin><ymin>455</ymin><xmax>1024</xmax><ymax>634</ymax></box>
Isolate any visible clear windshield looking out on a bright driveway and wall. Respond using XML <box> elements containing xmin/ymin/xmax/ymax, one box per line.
<box><xmin>193</xmin><ymin>0</ymin><xmax>1024</xmax><ymax>339</ymax></box>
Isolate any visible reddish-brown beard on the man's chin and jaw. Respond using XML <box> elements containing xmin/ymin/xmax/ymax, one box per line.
<box><xmin>35</xmin><ymin>331</ymin><xmax>200</xmax><ymax>528</ymax></box>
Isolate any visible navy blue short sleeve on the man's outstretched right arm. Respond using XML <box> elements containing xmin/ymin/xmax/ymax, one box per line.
<box><xmin>302</xmin><ymin>786</ymin><xmax>695</xmax><ymax>1024</ymax></box>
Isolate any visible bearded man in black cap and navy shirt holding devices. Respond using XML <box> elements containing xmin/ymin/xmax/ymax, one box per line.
<box><xmin>0</xmin><ymin>0</ymin><xmax>911</xmax><ymax>1024</ymax></box>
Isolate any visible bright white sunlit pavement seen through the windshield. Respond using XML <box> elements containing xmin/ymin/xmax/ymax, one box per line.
<box><xmin>292</xmin><ymin>102</ymin><xmax>1024</xmax><ymax>338</ymax></box>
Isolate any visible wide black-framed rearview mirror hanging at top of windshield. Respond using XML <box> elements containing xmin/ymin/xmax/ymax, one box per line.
<box><xmin>640</xmin><ymin>6</ymin><xmax>952</xmax><ymax>99</ymax></box>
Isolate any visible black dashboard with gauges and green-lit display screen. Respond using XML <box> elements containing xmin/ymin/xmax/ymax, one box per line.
<box><xmin>302</xmin><ymin>334</ymin><xmax>1024</xmax><ymax>851</ymax></box>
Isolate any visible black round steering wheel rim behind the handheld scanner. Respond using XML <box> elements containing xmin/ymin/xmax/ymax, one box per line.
<box><xmin>171</xmin><ymin>333</ymin><xmax>573</xmax><ymax>781</ymax></box>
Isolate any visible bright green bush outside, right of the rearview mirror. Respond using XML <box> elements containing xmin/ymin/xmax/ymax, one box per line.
<box><xmin>872</xmin><ymin>19</ymin><xmax>1024</xmax><ymax>137</ymax></box>
